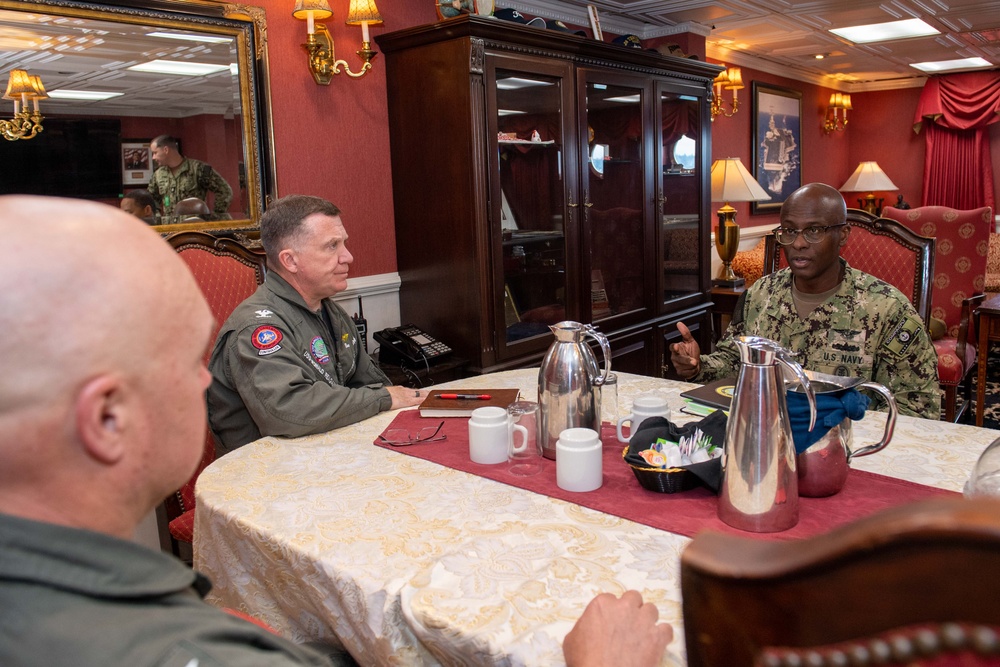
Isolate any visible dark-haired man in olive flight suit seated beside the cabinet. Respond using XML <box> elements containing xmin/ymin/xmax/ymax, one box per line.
<box><xmin>208</xmin><ymin>195</ymin><xmax>427</xmax><ymax>455</ymax></box>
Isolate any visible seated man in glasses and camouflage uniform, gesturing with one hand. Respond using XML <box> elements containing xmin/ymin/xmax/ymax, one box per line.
<box><xmin>670</xmin><ymin>183</ymin><xmax>941</xmax><ymax>419</ymax></box>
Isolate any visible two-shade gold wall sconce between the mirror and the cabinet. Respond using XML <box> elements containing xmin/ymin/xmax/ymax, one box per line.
<box><xmin>292</xmin><ymin>0</ymin><xmax>382</xmax><ymax>86</ymax></box>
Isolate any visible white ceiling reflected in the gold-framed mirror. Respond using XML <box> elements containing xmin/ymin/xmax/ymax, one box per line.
<box><xmin>0</xmin><ymin>10</ymin><xmax>240</xmax><ymax>118</ymax></box>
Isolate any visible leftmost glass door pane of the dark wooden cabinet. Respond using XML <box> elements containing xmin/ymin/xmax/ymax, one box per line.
<box><xmin>487</xmin><ymin>59</ymin><xmax>578</xmax><ymax>359</ymax></box>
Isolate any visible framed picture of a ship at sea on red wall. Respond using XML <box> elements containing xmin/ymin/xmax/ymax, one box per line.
<box><xmin>750</xmin><ymin>81</ymin><xmax>802</xmax><ymax>213</ymax></box>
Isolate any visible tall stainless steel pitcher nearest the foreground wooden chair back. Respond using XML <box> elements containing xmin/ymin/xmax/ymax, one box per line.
<box><xmin>719</xmin><ymin>336</ymin><xmax>816</xmax><ymax>533</ymax></box>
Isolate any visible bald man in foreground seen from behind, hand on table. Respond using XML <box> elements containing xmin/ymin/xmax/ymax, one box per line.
<box><xmin>0</xmin><ymin>196</ymin><xmax>672</xmax><ymax>667</ymax></box>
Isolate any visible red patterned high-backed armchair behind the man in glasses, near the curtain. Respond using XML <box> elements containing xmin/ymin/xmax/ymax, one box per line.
<box><xmin>882</xmin><ymin>206</ymin><xmax>993</xmax><ymax>421</ymax></box>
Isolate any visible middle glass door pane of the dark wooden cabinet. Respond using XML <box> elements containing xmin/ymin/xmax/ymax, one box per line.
<box><xmin>580</xmin><ymin>71</ymin><xmax>652</xmax><ymax>328</ymax></box>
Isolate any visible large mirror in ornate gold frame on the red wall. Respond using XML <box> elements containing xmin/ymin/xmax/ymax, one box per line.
<box><xmin>0</xmin><ymin>0</ymin><xmax>275</xmax><ymax>233</ymax></box>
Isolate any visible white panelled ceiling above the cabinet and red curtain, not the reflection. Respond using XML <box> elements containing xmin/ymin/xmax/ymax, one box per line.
<box><xmin>508</xmin><ymin>0</ymin><xmax>1000</xmax><ymax>92</ymax></box>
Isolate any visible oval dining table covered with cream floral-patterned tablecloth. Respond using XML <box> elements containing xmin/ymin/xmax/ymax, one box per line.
<box><xmin>194</xmin><ymin>368</ymin><xmax>1000</xmax><ymax>665</ymax></box>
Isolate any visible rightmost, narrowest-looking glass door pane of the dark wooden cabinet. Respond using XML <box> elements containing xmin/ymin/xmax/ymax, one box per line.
<box><xmin>658</xmin><ymin>89</ymin><xmax>708</xmax><ymax>303</ymax></box>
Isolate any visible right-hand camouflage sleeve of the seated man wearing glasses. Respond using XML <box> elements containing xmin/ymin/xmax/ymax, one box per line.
<box><xmin>874</xmin><ymin>308</ymin><xmax>941</xmax><ymax>420</ymax></box>
